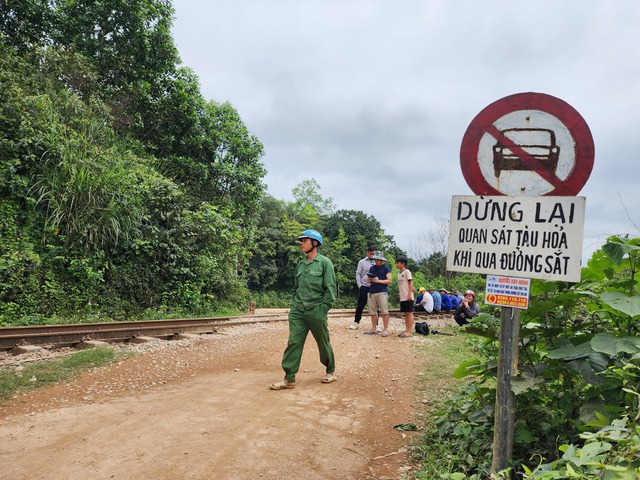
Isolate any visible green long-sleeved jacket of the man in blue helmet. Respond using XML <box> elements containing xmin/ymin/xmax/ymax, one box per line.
<box><xmin>292</xmin><ymin>253</ymin><xmax>338</xmax><ymax>311</ymax></box>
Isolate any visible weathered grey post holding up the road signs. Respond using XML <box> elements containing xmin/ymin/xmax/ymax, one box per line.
<box><xmin>491</xmin><ymin>307</ymin><xmax>520</xmax><ymax>473</ymax></box>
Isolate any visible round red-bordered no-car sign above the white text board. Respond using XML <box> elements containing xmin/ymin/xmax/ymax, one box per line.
<box><xmin>460</xmin><ymin>93</ymin><xmax>595</xmax><ymax>196</ymax></box>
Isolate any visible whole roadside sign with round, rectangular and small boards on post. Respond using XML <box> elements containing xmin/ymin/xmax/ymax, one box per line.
<box><xmin>456</xmin><ymin>93</ymin><xmax>595</xmax><ymax>473</ymax></box>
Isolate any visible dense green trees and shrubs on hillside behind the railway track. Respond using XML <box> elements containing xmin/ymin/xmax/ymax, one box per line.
<box><xmin>0</xmin><ymin>0</ymin><xmax>420</xmax><ymax>325</ymax></box>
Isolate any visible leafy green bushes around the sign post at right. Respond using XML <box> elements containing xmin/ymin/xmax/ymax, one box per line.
<box><xmin>418</xmin><ymin>237</ymin><xmax>640</xmax><ymax>479</ymax></box>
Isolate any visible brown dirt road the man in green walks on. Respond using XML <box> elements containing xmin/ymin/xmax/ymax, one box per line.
<box><xmin>0</xmin><ymin>317</ymin><xmax>456</xmax><ymax>480</ymax></box>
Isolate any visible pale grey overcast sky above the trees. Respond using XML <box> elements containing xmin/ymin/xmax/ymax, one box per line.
<box><xmin>173</xmin><ymin>0</ymin><xmax>640</xmax><ymax>259</ymax></box>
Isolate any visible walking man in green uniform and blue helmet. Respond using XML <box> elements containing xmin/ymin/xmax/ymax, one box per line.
<box><xmin>269</xmin><ymin>230</ymin><xmax>338</xmax><ymax>390</ymax></box>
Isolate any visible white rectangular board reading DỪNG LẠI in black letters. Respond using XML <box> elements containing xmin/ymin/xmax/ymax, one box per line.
<box><xmin>447</xmin><ymin>195</ymin><xmax>586</xmax><ymax>282</ymax></box>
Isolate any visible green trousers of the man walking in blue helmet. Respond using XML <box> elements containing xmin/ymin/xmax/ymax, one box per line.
<box><xmin>282</xmin><ymin>305</ymin><xmax>336</xmax><ymax>383</ymax></box>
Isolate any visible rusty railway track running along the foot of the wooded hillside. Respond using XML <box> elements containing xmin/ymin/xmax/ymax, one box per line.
<box><xmin>0</xmin><ymin>309</ymin><xmax>452</xmax><ymax>351</ymax></box>
